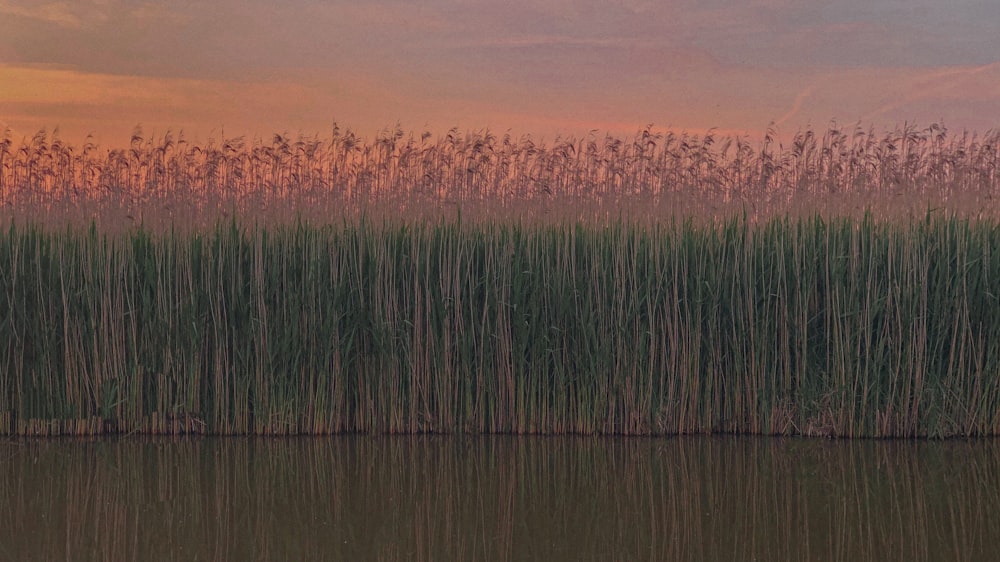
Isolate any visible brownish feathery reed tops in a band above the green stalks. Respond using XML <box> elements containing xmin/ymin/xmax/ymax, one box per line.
<box><xmin>0</xmin><ymin>123</ymin><xmax>1000</xmax><ymax>228</ymax></box>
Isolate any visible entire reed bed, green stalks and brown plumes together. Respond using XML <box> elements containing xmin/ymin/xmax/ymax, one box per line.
<box><xmin>0</xmin><ymin>122</ymin><xmax>1000</xmax><ymax>436</ymax></box>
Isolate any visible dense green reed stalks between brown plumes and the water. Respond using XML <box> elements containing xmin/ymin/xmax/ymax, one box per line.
<box><xmin>0</xmin><ymin>212</ymin><xmax>1000</xmax><ymax>437</ymax></box>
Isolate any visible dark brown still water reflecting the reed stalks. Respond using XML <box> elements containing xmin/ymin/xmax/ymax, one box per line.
<box><xmin>0</xmin><ymin>437</ymin><xmax>1000</xmax><ymax>562</ymax></box>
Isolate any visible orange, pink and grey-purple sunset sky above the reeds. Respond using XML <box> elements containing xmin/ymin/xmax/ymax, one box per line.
<box><xmin>0</xmin><ymin>0</ymin><xmax>1000</xmax><ymax>145</ymax></box>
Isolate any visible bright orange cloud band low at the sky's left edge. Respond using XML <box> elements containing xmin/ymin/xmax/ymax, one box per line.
<box><xmin>0</xmin><ymin>65</ymin><xmax>372</xmax><ymax>141</ymax></box>
